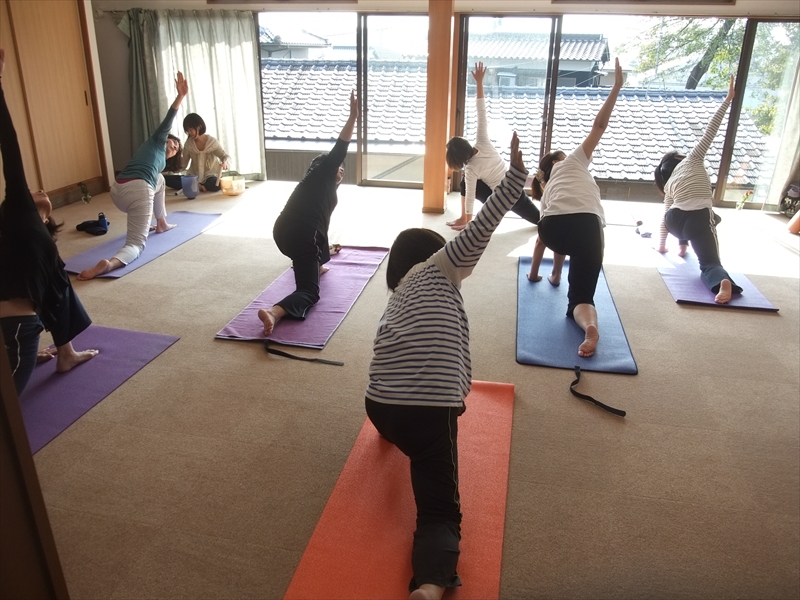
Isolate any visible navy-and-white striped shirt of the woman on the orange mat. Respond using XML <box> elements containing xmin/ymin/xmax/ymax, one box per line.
<box><xmin>366</xmin><ymin>165</ymin><xmax>527</xmax><ymax>407</ymax></box>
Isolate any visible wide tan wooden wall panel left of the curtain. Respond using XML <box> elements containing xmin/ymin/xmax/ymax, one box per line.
<box><xmin>8</xmin><ymin>0</ymin><xmax>102</xmax><ymax>191</ymax></box>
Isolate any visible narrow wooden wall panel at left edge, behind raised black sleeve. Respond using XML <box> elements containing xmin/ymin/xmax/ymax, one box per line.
<box><xmin>0</xmin><ymin>0</ymin><xmax>42</xmax><ymax>195</ymax></box>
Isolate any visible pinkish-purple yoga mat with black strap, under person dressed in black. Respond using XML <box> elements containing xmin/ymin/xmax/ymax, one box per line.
<box><xmin>216</xmin><ymin>246</ymin><xmax>389</xmax><ymax>349</ymax></box>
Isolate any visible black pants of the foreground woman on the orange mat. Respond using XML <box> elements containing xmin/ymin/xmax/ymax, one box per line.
<box><xmin>365</xmin><ymin>398</ymin><xmax>463</xmax><ymax>591</ymax></box>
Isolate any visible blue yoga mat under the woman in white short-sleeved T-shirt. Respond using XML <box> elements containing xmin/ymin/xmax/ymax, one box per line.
<box><xmin>517</xmin><ymin>256</ymin><xmax>639</xmax><ymax>375</ymax></box>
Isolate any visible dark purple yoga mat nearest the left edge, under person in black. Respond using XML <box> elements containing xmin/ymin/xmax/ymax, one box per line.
<box><xmin>19</xmin><ymin>325</ymin><xmax>179</xmax><ymax>452</ymax></box>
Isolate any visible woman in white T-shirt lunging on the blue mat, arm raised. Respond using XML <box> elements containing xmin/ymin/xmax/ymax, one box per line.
<box><xmin>533</xmin><ymin>59</ymin><xmax>623</xmax><ymax>357</ymax></box>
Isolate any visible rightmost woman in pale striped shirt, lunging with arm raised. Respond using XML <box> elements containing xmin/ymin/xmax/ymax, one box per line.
<box><xmin>654</xmin><ymin>75</ymin><xmax>742</xmax><ymax>304</ymax></box>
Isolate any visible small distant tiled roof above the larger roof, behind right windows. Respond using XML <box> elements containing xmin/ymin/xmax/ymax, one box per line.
<box><xmin>469</xmin><ymin>33</ymin><xmax>610</xmax><ymax>62</ymax></box>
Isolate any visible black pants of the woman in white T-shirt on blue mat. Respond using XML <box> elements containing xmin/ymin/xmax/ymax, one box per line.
<box><xmin>539</xmin><ymin>213</ymin><xmax>605</xmax><ymax>317</ymax></box>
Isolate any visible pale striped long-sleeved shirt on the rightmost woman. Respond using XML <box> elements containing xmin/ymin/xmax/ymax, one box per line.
<box><xmin>661</xmin><ymin>100</ymin><xmax>731</xmax><ymax>246</ymax></box>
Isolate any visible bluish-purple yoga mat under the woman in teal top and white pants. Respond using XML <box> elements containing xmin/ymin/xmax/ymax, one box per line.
<box><xmin>65</xmin><ymin>210</ymin><xmax>220</xmax><ymax>278</ymax></box>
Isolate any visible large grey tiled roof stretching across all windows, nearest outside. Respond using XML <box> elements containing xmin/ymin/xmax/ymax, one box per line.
<box><xmin>262</xmin><ymin>60</ymin><xmax>766</xmax><ymax>185</ymax></box>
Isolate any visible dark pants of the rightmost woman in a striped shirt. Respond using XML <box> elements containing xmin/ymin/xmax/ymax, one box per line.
<box><xmin>664</xmin><ymin>208</ymin><xmax>742</xmax><ymax>294</ymax></box>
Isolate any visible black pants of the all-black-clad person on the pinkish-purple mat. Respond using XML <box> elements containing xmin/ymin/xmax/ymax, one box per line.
<box><xmin>272</xmin><ymin>219</ymin><xmax>330</xmax><ymax>319</ymax></box>
